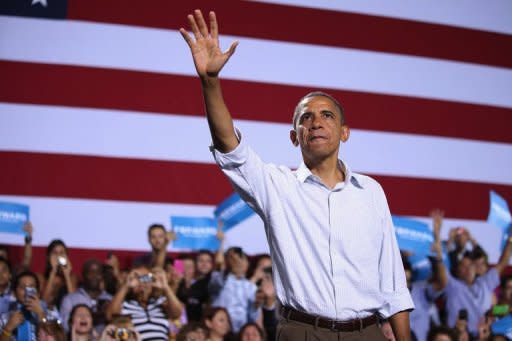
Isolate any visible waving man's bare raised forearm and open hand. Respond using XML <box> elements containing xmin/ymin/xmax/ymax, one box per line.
<box><xmin>180</xmin><ymin>10</ymin><xmax>238</xmax><ymax>153</ymax></box>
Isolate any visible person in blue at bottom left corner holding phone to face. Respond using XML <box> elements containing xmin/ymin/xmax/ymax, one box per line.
<box><xmin>0</xmin><ymin>271</ymin><xmax>59</xmax><ymax>341</ymax></box>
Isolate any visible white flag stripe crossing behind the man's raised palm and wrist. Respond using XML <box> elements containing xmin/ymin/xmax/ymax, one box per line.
<box><xmin>0</xmin><ymin>17</ymin><xmax>512</xmax><ymax>108</ymax></box>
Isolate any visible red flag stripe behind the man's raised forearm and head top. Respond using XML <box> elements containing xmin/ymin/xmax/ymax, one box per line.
<box><xmin>0</xmin><ymin>61</ymin><xmax>512</xmax><ymax>143</ymax></box>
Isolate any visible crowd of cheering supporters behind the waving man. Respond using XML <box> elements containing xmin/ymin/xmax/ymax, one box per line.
<box><xmin>0</xmin><ymin>210</ymin><xmax>512</xmax><ymax>341</ymax></box>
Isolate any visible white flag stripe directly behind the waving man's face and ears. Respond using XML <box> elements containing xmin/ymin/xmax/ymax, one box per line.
<box><xmin>0</xmin><ymin>103</ymin><xmax>512</xmax><ymax>185</ymax></box>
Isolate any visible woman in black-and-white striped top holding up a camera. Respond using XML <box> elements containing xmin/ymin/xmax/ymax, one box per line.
<box><xmin>107</xmin><ymin>265</ymin><xmax>183</xmax><ymax>340</ymax></box>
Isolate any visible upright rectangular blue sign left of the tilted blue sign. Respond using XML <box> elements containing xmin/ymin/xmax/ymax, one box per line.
<box><xmin>171</xmin><ymin>216</ymin><xmax>219</xmax><ymax>251</ymax></box>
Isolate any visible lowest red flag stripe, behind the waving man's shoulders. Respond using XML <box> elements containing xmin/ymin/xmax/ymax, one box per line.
<box><xmin>0</xmin><ymin>152</ymin><xmax>512</xmax><ymax>220</ymax></box>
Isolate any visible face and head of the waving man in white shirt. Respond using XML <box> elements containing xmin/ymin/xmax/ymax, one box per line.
<box><xmin>290</xmin><ymin>96</ymin><xmax>349</xmax><ymax>161</ymax></box>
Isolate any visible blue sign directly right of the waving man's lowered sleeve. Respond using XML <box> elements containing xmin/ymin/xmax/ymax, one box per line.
<box><xmin>392</xmin><ymin>216</ymin><xmax>434</xmax><ymax>256</ymax></box>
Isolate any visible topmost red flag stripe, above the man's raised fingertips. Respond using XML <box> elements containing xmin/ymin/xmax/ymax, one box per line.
<box><xmin>68</xmin><ymin>0</ymin><xmax>512</xmax><ymax>68</ymax></box>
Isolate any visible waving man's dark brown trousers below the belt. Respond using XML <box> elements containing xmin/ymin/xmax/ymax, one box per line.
<box><xmin>276</xmin><ymin>318</ymin><xmax>386</xmax><ymax>341</ymax></box>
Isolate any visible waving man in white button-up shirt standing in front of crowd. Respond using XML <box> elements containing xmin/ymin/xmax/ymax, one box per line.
<box><xmin>180</xmin><ymin>10</ymin><xmax>414</xmax><ymax>340</ymax></box>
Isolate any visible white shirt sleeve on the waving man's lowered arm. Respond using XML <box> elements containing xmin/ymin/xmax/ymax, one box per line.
<box><xmin>376</xmin><ymin>188</ymin><xmax>414</xmax><ymax>318</ymax></box>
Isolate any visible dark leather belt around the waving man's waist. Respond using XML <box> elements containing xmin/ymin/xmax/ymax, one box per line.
<box><xmin>281</xmin><ymin>307</ymin><xmax>378</xmax><ymax>332</ymax></box>
